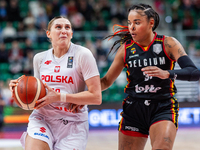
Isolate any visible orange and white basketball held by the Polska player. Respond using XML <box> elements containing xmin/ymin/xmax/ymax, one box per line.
<box><xmin>13</xmin><ymin>76</ymin><xmax>46</xmax><ymax>110</ymax></box>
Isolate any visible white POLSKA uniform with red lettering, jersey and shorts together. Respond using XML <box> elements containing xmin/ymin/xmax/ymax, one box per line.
<box><xmin>21</xmin><ymin>43</ymin><xmax>99</xmax><ymax>150</ymax></box>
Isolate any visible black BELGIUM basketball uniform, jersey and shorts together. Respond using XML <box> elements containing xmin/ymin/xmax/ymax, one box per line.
<box><xmin>119</xmin><ymin>33</ymin><xmax>179</xmax><ymax>137</ymax></box>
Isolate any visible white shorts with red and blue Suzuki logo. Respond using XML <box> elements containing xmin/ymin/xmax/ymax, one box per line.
<box><xmin>20</xmin><ymin>114</ymin><xmax>89</xmax><ymax>150</ymax></box>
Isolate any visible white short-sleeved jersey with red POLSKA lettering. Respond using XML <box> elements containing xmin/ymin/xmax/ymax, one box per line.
<box><xmin>33</xmin><ymin>43</ymin><xmax>99</xmax><ymax>121</ymax></box>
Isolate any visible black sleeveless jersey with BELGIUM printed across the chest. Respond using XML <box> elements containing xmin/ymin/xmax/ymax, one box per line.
<box><xmin>124</xmin><ymin>33</ymin><xmax>177</xmax><ymax>100</ymax></box>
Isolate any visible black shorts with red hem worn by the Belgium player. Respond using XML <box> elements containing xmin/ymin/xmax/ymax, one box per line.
<box><xmin>118</xmin><ymin>96</ymin><xmax>179</xmax><ymax>137</ymax></box>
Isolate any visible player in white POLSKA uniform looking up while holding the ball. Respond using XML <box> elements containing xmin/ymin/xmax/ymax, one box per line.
<box><xmin>9</xmin><ymin>17</ymin><xmax>102</xmax><ymax>150</ymax></box>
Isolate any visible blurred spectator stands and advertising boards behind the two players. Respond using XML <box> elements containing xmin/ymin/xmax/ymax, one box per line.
<box><xmin>0</xmin><ymin>0</ymin><xmax>200</xmax><ymax>148</ymax></box>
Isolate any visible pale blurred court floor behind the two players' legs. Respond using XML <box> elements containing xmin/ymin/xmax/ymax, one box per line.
<box><xmin>0</xmin><ymin>128</ymin><xmax>200</xmax><ymax>150</ymax></box>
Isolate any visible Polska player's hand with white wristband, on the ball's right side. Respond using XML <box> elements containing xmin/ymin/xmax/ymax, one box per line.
<box><xmin>35</xmin><ymin>84</ymin><xmax>60</xmax><ymax>109</ymax></box>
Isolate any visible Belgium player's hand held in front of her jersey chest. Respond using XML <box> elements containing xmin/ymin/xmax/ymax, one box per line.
<box><xmin>141</xmin><ymin>66</ymin><xmax>169</xmax><ymax>79</ymax></box>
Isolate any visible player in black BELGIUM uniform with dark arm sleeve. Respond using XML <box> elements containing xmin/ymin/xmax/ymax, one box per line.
<box><xmin>101</xmin><ymin>4</ymin><xmax>200</xmax><ymax>150</ymax></box>
